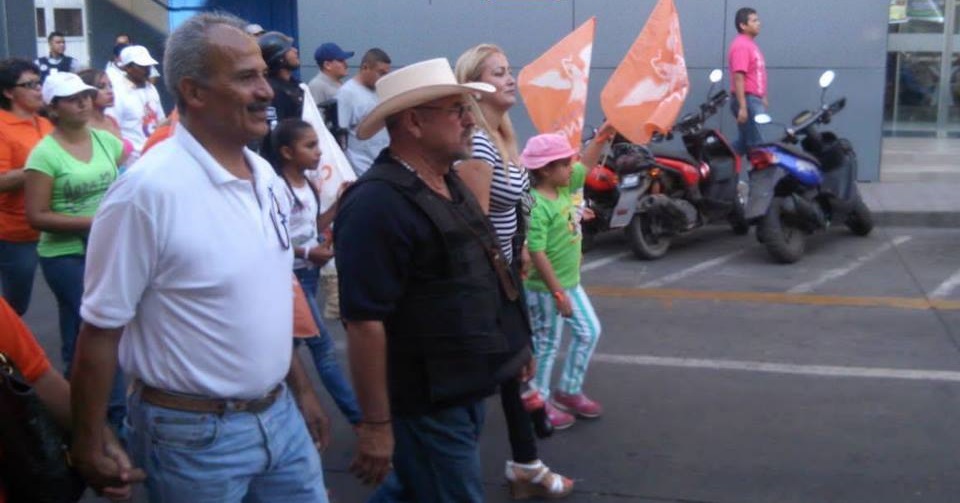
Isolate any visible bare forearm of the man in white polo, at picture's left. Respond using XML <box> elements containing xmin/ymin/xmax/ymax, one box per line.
<box><xmin>70</xmin><ymin>323</ymin><xmax>123</xmax><ymax>446</ymax></box>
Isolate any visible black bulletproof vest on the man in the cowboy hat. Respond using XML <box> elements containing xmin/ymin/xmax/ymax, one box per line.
<box><xmin>351</xmin><ymin>162</ymin><xmax>508</xmax><ymax>360</ymax></box>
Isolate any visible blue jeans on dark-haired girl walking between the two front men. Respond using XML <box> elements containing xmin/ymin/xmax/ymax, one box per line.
<box><xmin>293</xmin><ymin>267</ymin><xmax>362</xmax><ymax>424</ymax></box>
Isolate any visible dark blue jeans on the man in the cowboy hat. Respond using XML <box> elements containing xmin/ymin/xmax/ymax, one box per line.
<box><xmin>368</xmin><ymin>400</ymin><xmax>485</xmax><ymax>503</ymax></box>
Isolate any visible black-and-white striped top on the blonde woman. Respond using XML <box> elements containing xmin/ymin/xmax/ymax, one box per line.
<box><xmin>472</xmin><ymin>129</ymin><xmax>530</xmax><ymax>263</ymax></box>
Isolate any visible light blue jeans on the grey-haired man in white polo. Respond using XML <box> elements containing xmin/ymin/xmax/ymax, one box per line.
<box><xmin>127</xmin><ymin>389</ymin><xmax>327</xmax><ymax>503</ymax></box>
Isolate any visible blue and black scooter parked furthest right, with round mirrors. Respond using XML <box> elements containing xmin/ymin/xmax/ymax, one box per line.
<box><xmin>746</xmin><ymin>70</ymin><xmax>873</xmax><ymax>263</ymax></box>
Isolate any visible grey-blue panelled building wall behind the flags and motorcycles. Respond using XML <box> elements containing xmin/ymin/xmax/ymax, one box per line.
<box><xmin>300</xmin><ymin>0</ymin><xmax>889</xmax><ymax>180</ymax></box>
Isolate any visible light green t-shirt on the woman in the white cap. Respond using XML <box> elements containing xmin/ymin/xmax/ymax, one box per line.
<box><xmin>26</xmin><ymin>129</ymin><xmax>123</xmax><ymax>257</ymax></box>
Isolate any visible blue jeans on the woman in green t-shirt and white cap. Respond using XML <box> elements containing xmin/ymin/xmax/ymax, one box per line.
<box><xmin>40</xmin><ymin>255</ymin><xmax>127</xmax><ymax>431</ymax></box>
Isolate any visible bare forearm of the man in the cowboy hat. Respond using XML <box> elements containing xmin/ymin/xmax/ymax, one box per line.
<box><xmin>347</xmin><ymin>321</ymin><xmax>390</xmax><ymax>422</ymax></box>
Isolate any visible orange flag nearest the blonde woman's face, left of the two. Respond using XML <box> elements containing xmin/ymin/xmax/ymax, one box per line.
<box><xmin>518</xmin><ymin>17</ymin><xmax>597</xmax><ymax>149</ymax></box>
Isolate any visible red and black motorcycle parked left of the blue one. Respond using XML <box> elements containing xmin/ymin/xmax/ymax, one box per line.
<box><xmin>584</xmin><ymin>70</ymin><xmax>749</xmax><ymax>260</ymax></box>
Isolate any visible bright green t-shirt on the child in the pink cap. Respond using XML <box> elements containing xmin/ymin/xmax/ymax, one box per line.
<box><xmin>524</xmin><ymin>162</ymin><xmax>587</xmax><ymax>292</ymax></box>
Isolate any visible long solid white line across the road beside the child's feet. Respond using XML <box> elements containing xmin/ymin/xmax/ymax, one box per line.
<box><xmin>592</xmin><ymin>353</ymin><xmax>960</xmax><ymax>382</ymax></box>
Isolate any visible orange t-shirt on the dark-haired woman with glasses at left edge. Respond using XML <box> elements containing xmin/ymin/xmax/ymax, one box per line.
<box><xmin>0</xmin><ymin>109</ymin><xmax>53</xmax><ymax>242</ymax></box>
